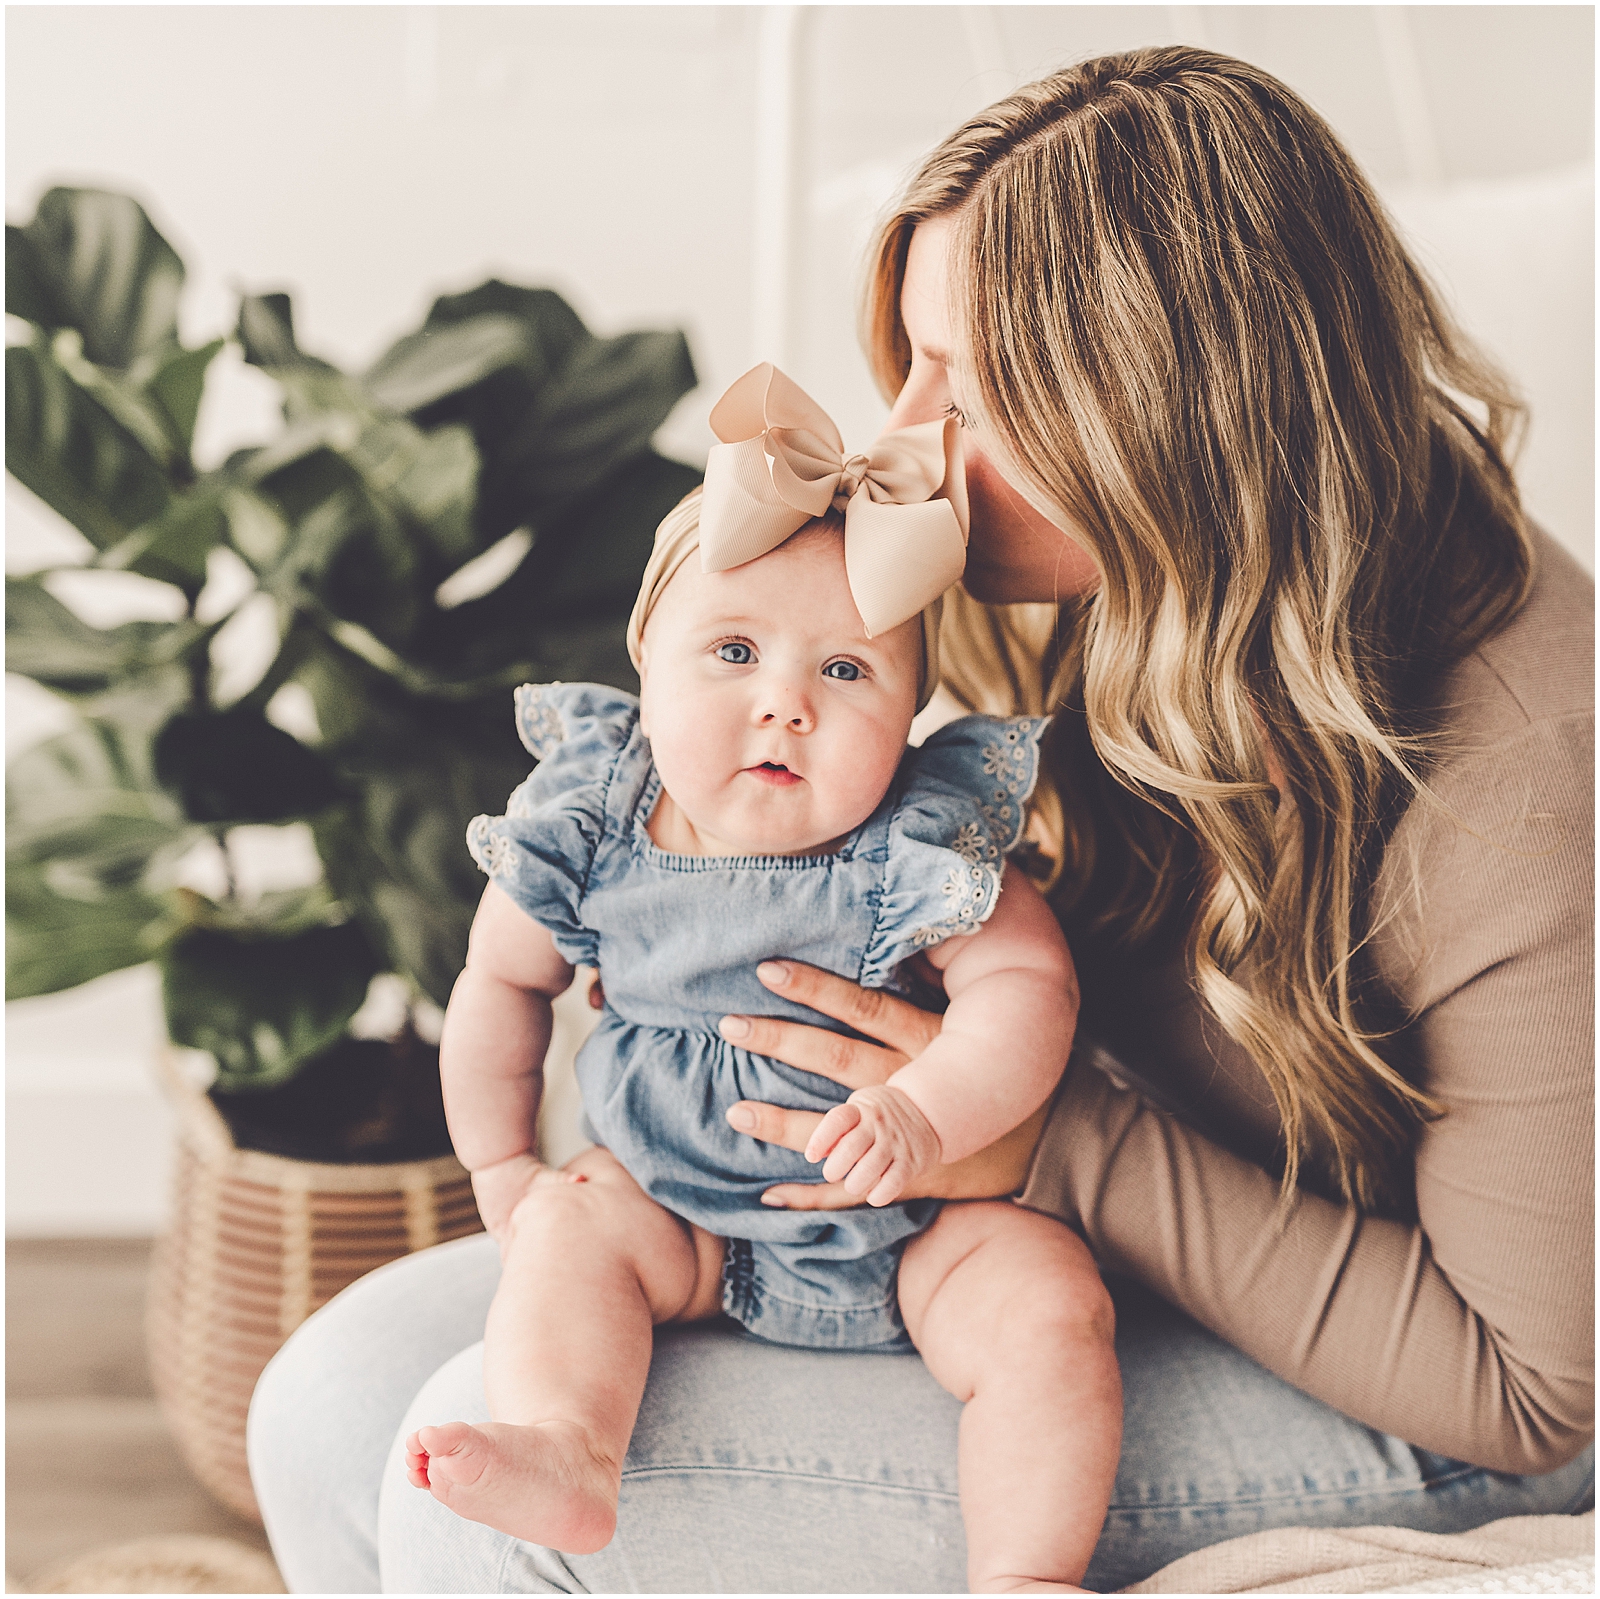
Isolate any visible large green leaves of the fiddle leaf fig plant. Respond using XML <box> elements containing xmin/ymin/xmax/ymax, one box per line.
<box><xmin>6</xmin><ymin>189</ymin><xmax>699</xmax><ymax>1152</ymax></box>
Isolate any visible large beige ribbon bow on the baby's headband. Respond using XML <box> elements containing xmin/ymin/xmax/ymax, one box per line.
<box><xmin>699</xmin><ymin>362</ymin><xmax>966</xmax><ymax>639</ymax></box>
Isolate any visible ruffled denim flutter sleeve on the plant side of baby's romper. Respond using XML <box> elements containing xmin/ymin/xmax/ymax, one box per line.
<box><xmin>467</xmin><ymin>683</ymin><xmax>638</xmax><ymax>965</ymax></box>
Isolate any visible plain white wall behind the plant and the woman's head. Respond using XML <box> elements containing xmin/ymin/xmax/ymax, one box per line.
<box><xmin>5</xmin><ymin>5</ymin><xmax>1594</xmax><ymax>1234</ymax></box>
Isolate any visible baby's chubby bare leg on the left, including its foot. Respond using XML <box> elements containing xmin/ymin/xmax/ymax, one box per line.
<box><xmin>406</xmin><ymin>1149</ymin><xmax>723</xmax><ymax>1554</ymax></box>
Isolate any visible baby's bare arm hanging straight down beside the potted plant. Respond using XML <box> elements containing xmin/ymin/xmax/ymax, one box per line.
<box><xmin>438</xmin><ymin>884</ymin><xmax>573</xmax><ymax>1237</ymax></box>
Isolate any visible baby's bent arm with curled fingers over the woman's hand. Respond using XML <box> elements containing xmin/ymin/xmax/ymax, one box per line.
<box><xmin>805</xmin><ymin>871</ymin><xmax>1078</xmax><ymax>1205</ymax></box>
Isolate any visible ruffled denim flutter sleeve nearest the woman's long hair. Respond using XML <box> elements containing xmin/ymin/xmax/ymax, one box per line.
<box><xmin>861</xmin><ymin>715</ymin><xmax>1048</xmax><ymax>988</ymax></box>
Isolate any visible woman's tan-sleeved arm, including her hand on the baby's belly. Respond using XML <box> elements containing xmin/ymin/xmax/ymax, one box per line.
<box><xmin>730</xmin><ymin>723</ymin><xmax>1594</xmax><ymax>1473</ymax></box>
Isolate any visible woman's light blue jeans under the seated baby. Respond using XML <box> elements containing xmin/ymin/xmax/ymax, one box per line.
<box><xmin>250</xmin><ymin>1234</ymin><xmax>1594</xmax><ymax>1594</ymax></box>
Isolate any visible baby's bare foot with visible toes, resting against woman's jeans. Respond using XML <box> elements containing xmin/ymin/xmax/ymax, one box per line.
<box><xmin>405</xmin><ymin>1421</ymin><xmax>621</xmax><ymax>1554</ymax></box>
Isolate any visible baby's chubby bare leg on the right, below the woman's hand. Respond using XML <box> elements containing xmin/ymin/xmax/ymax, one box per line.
<box><xmin>899</xmin><ymin>1200</ymin><xmax>1122</xmax><ymax>1593</ymax></box>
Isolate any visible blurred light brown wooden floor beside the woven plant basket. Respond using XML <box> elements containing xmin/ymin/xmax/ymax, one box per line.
<box><xmin>5</xmin><ymin>1239</ymin><xmax>278</xmax><ymax>1586</ymax></box>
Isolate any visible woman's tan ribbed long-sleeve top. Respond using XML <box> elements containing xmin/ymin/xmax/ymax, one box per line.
<box><xmin>1022</xmin><ymin>535</ymin><xmax>1595</xmax><ymax>1473</ymax></box>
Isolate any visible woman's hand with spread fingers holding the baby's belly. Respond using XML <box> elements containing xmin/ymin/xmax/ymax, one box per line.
<box><xmin>720</xmin><ymin>960</ymin><xmax>1048</xmax><ymax>1210</ymax></box>
